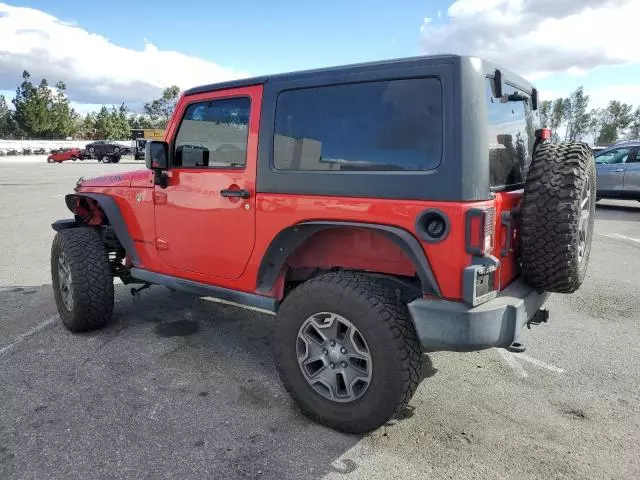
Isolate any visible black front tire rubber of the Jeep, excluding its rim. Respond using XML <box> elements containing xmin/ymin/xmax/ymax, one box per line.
<box><xmin>51</xmin><ymin>227</ymin><xmax>113</xmax><ymax>332</ymax></box>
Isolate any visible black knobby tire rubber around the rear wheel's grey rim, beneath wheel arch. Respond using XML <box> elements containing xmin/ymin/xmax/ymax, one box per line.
<box><xmin>273</xmin><ymin>272</ymin><xmax>422</xmax><ymax>433</ymax></box>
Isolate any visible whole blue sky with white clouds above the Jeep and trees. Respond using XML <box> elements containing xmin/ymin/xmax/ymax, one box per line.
<box><xmin>0</xmin><ymin>0</ymin><xmax>640</xmax><ymax>113</ymax></box>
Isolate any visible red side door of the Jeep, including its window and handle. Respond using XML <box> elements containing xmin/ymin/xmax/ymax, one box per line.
<box><xmin>154</xmin><ymin>85</ymin><xmax>262</xmax><ymax>282</ymax></box>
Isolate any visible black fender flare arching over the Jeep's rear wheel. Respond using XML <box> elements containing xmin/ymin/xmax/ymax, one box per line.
<box><xmin>256</xmin><ymin>221</ymin><xmax>442</xmax><ymax>297</ymax></box>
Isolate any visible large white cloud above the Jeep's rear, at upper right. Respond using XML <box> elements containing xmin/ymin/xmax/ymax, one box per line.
<box><xmin>420</xmin><ymin>0</ymin><xmax>640</xmax><ymax>80</ymax></box>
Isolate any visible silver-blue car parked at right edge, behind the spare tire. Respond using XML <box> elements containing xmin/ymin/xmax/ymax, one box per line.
<box><xmin>595</xmin><ymin>140</ymin><xmax>640</xmax><ymax>200</ymax></box>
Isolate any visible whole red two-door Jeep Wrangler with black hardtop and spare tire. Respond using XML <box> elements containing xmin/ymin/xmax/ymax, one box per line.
<box><xmin>51</xmin><ymin>56</ymin><xmax>595</xmax><ymax>432</ymax></box>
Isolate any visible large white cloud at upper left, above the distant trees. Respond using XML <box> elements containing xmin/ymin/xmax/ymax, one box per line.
<box><xmin>0</xmin><ymin>3</ymin><xmax>247</xmax><ymax>103</ymax></box>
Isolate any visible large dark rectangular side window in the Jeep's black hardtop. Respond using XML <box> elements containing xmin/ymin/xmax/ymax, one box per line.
<box><xmin>273</xmin><ymin>78</ymin><xmax>442</xmax><ymax>172</ymax></box>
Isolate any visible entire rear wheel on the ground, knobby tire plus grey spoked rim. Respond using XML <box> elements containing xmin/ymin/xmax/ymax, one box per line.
<box><xmin>273</xmin><ymin>272</ymin><xmax>422</xmax><ymax>433</ymax></box>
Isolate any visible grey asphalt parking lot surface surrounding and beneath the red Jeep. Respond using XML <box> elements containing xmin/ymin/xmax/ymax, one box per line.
<box><xmin>0</xmin><ymin>159</ymin><xmax>640</xmax><ymax>480</ymax></box>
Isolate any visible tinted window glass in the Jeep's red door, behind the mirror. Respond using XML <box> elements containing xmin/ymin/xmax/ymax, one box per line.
<box><xmin>173</xmin><ymin>97</ymin><xmax>251</xmax><ymax>168</ymax></box>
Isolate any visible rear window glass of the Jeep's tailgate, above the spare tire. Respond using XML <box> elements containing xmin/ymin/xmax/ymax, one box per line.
<box><xmin>486</xmin><ymin>79</ymin><xmax>538</xmax><ymax>189</ymax></box>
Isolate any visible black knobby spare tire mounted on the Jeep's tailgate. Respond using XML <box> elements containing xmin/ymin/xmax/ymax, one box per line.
<box><xmin>520</xmin><ymin>142</ymin><xmax>596</xmax><ymax>293</ymax></box>
